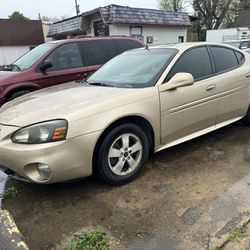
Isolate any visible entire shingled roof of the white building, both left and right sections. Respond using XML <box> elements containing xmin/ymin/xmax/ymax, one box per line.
<box><xmin>48</xmin><ymin>4</ymin><xmax>191</xmax><ymax>37</ymax></box>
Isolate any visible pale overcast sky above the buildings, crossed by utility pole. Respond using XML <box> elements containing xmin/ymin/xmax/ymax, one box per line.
<box><xmin>0</xmin><ymin>0</ymin><xmax>158</xmax><ymax>19</ymax></box>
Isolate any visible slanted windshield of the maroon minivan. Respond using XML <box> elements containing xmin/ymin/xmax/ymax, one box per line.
<box><xmin>12</xmin><ymin>43</ymin><xmax>54</xmax><ymax>71</ymax></box>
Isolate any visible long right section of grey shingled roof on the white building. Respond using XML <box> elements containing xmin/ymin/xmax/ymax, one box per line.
<box><xmin>99</xmin><ymin>4</ymin><xmax>191</xmax><ymax>26</ymax></box>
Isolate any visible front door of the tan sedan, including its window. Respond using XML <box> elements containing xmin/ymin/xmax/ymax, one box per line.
<box><xmin>160</xmin><ymin>46</ymin><xmax>218</xmax><ymax>146</ymax></box>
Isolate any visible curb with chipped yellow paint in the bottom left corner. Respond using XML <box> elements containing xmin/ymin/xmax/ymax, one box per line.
<box><xmin>0</xmin><ymin>210</ymin><xmax>29</xmax><ymax>250</ymax></box>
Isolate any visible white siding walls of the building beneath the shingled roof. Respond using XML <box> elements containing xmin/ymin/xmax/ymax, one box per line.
<box><xmin>109</xmin><ymin>24</ymin><xmax>187</xmax><ymax>44</ymax></box>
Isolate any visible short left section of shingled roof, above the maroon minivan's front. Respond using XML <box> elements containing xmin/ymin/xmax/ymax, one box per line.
<box><xmin>47</xmin><ymin>15</ymin><xmax>82</xmax><ymax>37</ymax></box>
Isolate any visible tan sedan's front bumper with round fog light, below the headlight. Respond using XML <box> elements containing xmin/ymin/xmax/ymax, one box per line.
<box><xmin>0</xmin><ymin>126</ymin><xmax>99</xmax><ymax>184</ymax></box>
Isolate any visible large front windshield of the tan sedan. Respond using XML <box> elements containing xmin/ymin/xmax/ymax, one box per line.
<box><xmin>87</xmin><ymin>48</ymin><xmax>178</xmax><ymax>88</ymax></box>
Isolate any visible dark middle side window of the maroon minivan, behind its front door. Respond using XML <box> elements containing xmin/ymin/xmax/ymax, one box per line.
<box><xmin>79</xmin><ymin>40</ymin><xmax>118</xmax><ymax>66</ymax></box>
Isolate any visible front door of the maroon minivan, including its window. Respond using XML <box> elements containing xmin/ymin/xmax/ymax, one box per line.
<box><xmin>40</xmin><ymin>43</ymin><xmax>88</xmax><ymax>87</ymax></box>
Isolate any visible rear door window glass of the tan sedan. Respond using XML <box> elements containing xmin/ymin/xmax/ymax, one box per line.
<box><xmin>211</xmin><ymin>47</ymin><xmax>239</xmax><ymax>73</ymax></box>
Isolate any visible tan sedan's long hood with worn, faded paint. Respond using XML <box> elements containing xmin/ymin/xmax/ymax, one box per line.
<box><xmin>0</xmin><ymin>82</ymin><xmax>152</xmax><ymax>127</ymax></box>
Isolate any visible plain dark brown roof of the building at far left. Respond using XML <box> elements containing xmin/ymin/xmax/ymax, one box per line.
<box><xmin>0</xmin><ymin>19</ymin><xmax>44</xmax><ymax>46</ymax></box>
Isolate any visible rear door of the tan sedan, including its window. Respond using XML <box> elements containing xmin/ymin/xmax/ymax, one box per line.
<box><xmin>210</xmin><ymin>46</ymin><xmax>250</xmax><ymax>124</ymax></box>
